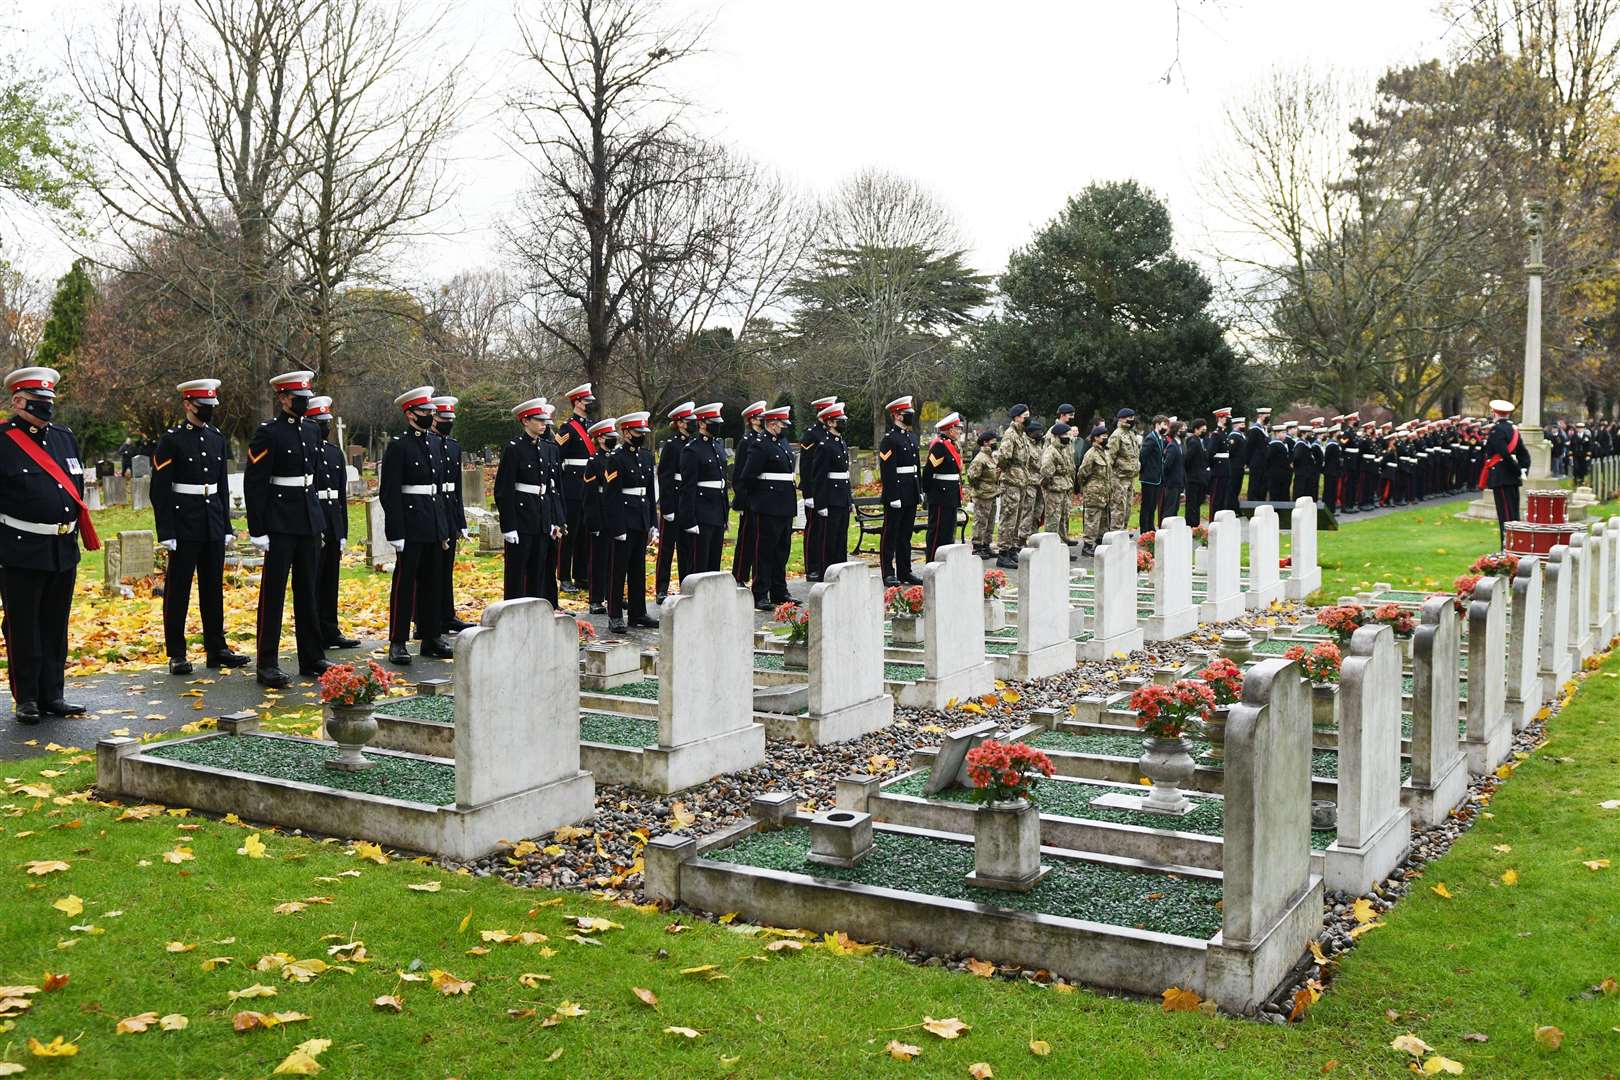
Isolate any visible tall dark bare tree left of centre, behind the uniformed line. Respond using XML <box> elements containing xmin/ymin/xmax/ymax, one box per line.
<box><xmin>507</xmin><ymin>0</ymin><xmax>708</xmax><ymax>382</ymax></box>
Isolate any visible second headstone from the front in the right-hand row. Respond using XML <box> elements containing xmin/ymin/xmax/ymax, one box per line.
<box><xmin>1324</xmin><ymin>625</ymin><xmax>1411</xmax><ymax>895</ymax></box>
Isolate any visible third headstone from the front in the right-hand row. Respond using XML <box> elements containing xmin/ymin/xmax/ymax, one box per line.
<box><xmin>1408</xmin><ymin>596</ymin><xmax>1468</xmax><ymax>827</ymax></box>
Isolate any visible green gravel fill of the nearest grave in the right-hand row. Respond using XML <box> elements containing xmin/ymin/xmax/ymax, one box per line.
<box><xmin>708</xmin><ymin>826</ymin><xmax>1221</xmax><ymax>939</ymax></box>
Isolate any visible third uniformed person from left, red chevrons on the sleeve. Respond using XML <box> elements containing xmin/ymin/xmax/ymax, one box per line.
<box><xmin>241</xmin><ymin>371</ymin><xmax>332</xmax><ymax>688</ymax></box>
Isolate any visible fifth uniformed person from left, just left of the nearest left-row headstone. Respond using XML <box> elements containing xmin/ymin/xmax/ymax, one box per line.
<box><xmin>377</xmin><ymin>387</ymin><xmax>454</xmax><ymax>665</ymax></box>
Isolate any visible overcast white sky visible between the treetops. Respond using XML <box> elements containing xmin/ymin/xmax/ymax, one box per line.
<box><xmin>8</xmin><ymin>0</ymin><xmax>1447</xmax><ymax>277</ymax></box>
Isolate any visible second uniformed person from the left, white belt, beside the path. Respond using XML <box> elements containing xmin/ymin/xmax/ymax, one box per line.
<box><xmin>152</xmin><ymin>379</ymin><xmax>248</xmax><ymax>675</ymax></box>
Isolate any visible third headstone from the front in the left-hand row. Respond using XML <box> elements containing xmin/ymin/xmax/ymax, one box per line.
<box><xmin>810</xmin><ymin>562</ymin><xmax>894</xmax><ymax>743</ymax></box>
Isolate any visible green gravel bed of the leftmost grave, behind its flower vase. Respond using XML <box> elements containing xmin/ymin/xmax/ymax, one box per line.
<box><xmin>144</xmin><ymin>735</ymin><xmax>455</xmax><ymax>806</ymax></box>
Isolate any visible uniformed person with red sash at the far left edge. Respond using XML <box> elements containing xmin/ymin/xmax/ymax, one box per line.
<box><xmin>0</xmin><ymin>368</ymin><xmax>100</xmax><ymax>724</ymax></box>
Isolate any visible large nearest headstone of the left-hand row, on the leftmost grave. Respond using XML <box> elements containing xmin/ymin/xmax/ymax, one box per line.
<box><xmin>455</xmin><ymin>599</ymin><xmax>596</xmax><ymax>822</ymax></box>
